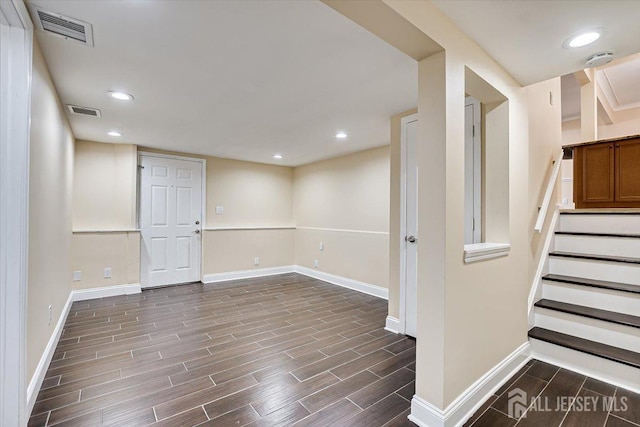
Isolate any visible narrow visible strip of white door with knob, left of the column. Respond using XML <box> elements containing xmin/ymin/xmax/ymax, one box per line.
<box><xmin>403</xmin><ymin>117</ymin><xmax>418</xmax><ymax>337</ymax></box>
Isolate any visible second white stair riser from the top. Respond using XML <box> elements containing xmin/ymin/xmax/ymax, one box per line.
<box><xmin>555</xmin><ymin>234</ymin><xmax>640</xmax><ymax>257</ymax></box>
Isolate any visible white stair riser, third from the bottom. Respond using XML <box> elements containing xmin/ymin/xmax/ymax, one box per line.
<box><xmin>542</xmin><ymin>280</ymin><xmax>640</xmax><ymax>316</ymax></box>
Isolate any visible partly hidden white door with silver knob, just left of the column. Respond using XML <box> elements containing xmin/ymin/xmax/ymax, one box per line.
<box><xmin>400</xmin><ymin>115</ymin><xmax>418</xmax><ymax>337</ymax></box>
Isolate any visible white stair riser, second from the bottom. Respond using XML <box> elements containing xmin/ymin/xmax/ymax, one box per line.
<box><xmin>535</xmin><ymin>307</ymin><xmax>640</xmax><ymax>353</ymax></box>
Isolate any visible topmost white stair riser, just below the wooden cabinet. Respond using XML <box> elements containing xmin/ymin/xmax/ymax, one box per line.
<box><xmin>559</xmin><ymin>215</ymin><xmax>640</xmax><ymax>234</ymax></box>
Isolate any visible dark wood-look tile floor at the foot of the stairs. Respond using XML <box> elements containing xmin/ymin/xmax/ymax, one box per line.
<box><xmin>465</xmin><ymin>360</ymin><xmax>640</xmax><ymax>427</ymax></box>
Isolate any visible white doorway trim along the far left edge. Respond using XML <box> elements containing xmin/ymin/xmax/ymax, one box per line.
<box><xmin>0</xmin><ymin>0</ymin><xmax>33</xmax><ymax>427</ymax></box>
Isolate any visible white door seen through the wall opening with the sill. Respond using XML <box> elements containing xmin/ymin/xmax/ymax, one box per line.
<box><xmin>464</xmin><ymin>96</ymin><xmax>482</xmax><ymax>244</ymax></box>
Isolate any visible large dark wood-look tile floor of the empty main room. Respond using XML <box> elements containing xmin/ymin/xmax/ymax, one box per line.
<box><xmin>29</xmin><ymin>274</ymin><xmax>420</xmax><ymax>427</ymax></box>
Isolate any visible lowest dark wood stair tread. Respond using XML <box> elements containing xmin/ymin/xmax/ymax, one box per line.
<box><xmin>529</xmin><ymin>327</ymin><xmax>640</xmax><ymax>368</ymax></box>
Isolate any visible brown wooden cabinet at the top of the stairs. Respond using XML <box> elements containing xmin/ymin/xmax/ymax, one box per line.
<box><xmin>573</xmin><ymin>137</ymin><xmax>640</xmax><ymax>209</ymax></box>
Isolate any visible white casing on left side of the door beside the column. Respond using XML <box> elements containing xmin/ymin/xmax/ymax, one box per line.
<box><xmin>397</xmin><ymin>113</ymin><xmax>418</xmax><ymax>334</ymax></box>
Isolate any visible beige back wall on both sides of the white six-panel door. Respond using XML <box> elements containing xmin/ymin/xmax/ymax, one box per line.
<box><xmin>72</xmin><ymin>145</ymin><xmax>294</xmax><ymax>280</ymax></box>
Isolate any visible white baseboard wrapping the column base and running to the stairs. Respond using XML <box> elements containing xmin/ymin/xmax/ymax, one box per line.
<box><xmin>409</xmin><ymin>342</ymin><xmax>531</xmax><ymax>427</ymax></box>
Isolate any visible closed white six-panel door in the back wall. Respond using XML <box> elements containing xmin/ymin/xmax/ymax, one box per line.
<box><xmin>140</xmin><ymin>155</ymin><xmax>202</xmax><ymax>287</ymax></box>
